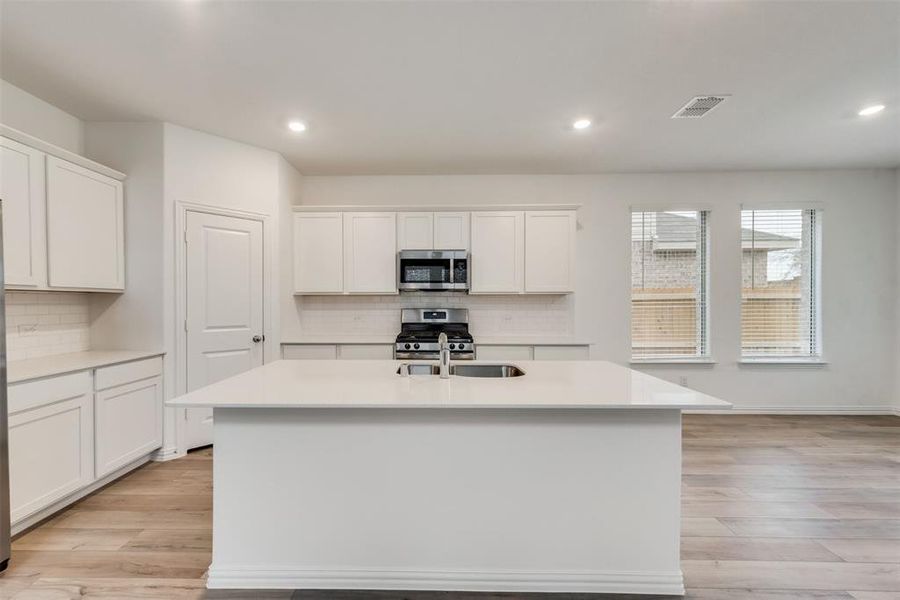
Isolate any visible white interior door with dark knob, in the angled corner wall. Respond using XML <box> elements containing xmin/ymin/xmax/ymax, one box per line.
<box><xmin>185</xmin><ymin>211</ymin><xmax>263</xmax><ymax>449</ymax></box>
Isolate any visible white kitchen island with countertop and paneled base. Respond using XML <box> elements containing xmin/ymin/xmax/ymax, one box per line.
<box><xmin>169</xmin><ymin>360</ymin><xmax>730</xmax><ymax>595</ymax></box>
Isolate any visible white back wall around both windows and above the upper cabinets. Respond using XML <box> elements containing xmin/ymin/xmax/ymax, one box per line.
<box><xmin>298</xmin><ymin>170</ymin><xmax>898</xmax><ymax>411</ymax></box>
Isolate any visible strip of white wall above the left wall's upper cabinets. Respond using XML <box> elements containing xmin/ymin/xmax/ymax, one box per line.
<box><xmin>0</xmin><ymin>79</ymin><xmax>84</xmax><ymax>154</ymax></box>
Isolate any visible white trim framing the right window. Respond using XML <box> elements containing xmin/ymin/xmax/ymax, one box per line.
<box><xmin>737</xmin><ymin>202</ymin><xmax>829</xmax><ymax>360</ymax></box>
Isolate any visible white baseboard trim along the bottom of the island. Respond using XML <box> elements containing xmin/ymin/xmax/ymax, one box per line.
<box><xmin>207</xmin><ymin>565</ymin><xmax>684</xmax><ymax>596</ymax></box>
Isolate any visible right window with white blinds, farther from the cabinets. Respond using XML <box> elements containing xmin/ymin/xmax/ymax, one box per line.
<box><xmin>741</xmin><ymin>209</ymin><xmax>821</xmax><ymax>359</ymax></box>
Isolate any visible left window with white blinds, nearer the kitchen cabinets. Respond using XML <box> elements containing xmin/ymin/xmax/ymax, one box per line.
<box><xmin>631</xmin><ymin>211</ymin><xmax>709</xmax><ymax>360</ymax></box>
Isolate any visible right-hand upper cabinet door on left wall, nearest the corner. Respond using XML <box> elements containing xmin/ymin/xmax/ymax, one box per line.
<box><xmin>47</xmin><ymin>156</ymin><xmax>125</xmax><ymax>290</ymax></box>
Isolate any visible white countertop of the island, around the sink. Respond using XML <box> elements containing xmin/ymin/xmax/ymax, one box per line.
<box><xmin>167</xmin><ymin>360</ymin><xmax>731</xmax><ymax>409</ymax></box>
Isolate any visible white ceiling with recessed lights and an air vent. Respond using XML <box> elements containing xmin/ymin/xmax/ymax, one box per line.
<box><xmin>0</xmin><ymin>0</ymin><xmax>900</xmax><ymax>174</ymax></box>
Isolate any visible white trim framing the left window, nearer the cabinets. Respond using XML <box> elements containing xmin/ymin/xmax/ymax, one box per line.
<box><xmin>626</xmin><ymin>209</ymin><xmax>718</xmax><ymax>365</ymax></box>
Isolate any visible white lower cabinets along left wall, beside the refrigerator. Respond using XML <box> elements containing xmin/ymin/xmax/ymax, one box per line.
<box><xmin>9</xmin><ymin>357</ymin><xmax>163</xmax><ymax>531</ymax></box>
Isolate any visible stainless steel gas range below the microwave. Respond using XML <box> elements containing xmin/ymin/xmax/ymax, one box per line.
<box><xmin>394</xmin><ymin>308</ymin><xmax>475</xmax><ymax>360</ymax></box>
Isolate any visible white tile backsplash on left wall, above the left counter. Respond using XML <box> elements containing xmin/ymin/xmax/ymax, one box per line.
<box><xmin>6</xmin><ymin>291</ymin><xmax>90</xmax><ymax>360</ymax></box>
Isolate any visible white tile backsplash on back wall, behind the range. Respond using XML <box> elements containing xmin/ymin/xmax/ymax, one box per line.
<box><xmin>295</xmin><ymin>292</ymin><xmax>574</xmax><ymax>341</ymax></box>
